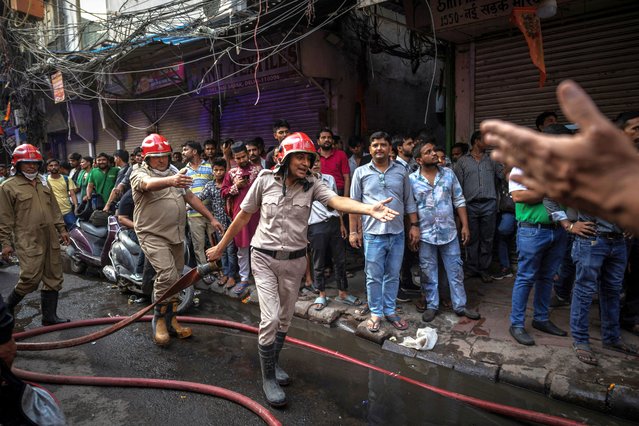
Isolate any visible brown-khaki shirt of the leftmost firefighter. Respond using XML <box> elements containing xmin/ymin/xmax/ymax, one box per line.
<box><xmin>0</xmin><ymin>174</ymin><xmax>66</xmax><ymax>255</ymax></box>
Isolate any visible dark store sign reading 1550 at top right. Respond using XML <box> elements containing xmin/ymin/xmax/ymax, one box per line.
<box><xmin>430</xmin><ymin>0</ymin><xmax>540</xmax><ymax>31</ymax></box>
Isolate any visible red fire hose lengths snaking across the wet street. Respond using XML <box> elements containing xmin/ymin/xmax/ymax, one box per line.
<box><xmin>13</xmin><ymin>265</ymin><xmax>583</xmax><ymax>426</ymax></box>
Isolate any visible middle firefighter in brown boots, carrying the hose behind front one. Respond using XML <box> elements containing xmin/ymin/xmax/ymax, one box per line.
<box><xmin>131</xmin><ymin>133</ymin><xmax>224</xmax><ymax>346</ymax></box>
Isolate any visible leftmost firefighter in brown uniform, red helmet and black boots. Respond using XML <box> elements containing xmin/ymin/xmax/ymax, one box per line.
<box><xmin>0</xmin><ymin>144</ymin><xmax>69</xmax><ymax>325</ymax></box>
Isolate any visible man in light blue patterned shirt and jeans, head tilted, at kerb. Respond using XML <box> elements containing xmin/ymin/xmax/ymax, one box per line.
<box><xmin>409</xmin><ymin>143</ymin><xmax>480</xmax><ymax>322</ymax></box>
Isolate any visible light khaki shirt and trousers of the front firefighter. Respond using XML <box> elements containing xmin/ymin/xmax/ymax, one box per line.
<box><xmin>240</xmin><ymin>170</ymin><xmax>337</xmax><ymax>345</ymax></box>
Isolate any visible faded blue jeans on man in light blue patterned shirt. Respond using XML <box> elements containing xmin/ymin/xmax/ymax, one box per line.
<box><xmin>419</xmin><ymin>237</ymin><xmax>466</xmax><ymax>312</ymax></box>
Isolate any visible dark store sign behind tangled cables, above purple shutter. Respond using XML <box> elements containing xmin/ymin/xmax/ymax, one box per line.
<box><xmin>187</xmin><ymin>44</ymin><xmax>300</xmax><ymax>96</ymax></box>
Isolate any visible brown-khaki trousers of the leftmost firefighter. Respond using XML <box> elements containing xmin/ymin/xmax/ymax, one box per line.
<box><xmin>15</xmin><ymin>226</ymin><xmax>63</xmax><ymax>296</ymax></box>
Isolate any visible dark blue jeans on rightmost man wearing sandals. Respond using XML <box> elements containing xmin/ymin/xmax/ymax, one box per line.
<box><xmin>570</xmin><ymin>236</ymin><xmax>628</xmax><ymax>345</ymax></box>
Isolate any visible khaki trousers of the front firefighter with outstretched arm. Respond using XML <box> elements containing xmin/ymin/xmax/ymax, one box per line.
<box><xmin>251</xmin><ymin>250</ymin><xmax>306</xmax><ymax>345</ymax></box>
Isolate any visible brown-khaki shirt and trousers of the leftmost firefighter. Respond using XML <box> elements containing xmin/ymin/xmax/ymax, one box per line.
<box><xmin>0</xmin><ymin>174</ymin><xmax>67</xmax><ymax>296</ymax></box>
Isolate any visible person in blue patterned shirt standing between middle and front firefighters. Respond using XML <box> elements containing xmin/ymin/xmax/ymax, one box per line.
<box><xmin>197</xmin><ymin>158</ymin><xmax>237</xmax><ymax>288</ymax></box>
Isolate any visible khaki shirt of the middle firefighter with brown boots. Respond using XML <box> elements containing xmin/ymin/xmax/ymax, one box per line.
<box><xmin>131</xmin><ymin>164</ymin><xmax>186</xmax><ymax>244</ymax></box>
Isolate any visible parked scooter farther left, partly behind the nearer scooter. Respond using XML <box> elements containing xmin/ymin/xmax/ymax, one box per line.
<box><xmin>67</xmin><ymin>216</ymin><xmax>120</xmax><ymax>274</ymax></box>
